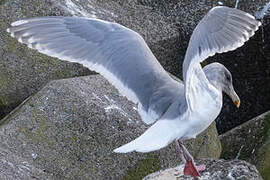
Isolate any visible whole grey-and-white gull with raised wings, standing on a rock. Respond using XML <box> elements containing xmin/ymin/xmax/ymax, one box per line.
<box><xmin>7</xmin><ymin>6</ymin><xmax>261</xmax><ymax>177</ymax></box>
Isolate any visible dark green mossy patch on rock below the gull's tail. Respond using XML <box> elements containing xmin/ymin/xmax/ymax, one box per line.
<box><xmin>123</xmin><ymin>154</ymin><xmax>160</xmax><ymax>180</ymax></box>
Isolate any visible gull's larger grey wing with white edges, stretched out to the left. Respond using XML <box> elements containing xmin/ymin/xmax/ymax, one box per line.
<box><xmin>7</xmin><ymin>17</ymin><xmax>183</xmax><ymax>123</ymax></box>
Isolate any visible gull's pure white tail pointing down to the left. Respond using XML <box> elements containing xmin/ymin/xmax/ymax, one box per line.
<box><xmin>114</xmin><ymin>120</ymin><xmax>181</xmax><ymax>153</ymax></box>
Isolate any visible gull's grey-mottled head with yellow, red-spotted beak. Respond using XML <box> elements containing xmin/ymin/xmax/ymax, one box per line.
<box><xmin>203</xmin><ymin>63</ymin><xmax>240</xmax><ymax>108</ymax></box>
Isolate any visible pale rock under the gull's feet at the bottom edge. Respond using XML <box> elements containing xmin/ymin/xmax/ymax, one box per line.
<box><xmin>143</xmin><ymin>159</ymin><xmax>262</xmax><ymax>180</ymax></box>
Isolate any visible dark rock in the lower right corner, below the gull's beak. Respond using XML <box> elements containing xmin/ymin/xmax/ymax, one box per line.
<box><xmin>220</xmin><ymin>111</ymin><xmax>270</xmax><ymax>179</ymax></box>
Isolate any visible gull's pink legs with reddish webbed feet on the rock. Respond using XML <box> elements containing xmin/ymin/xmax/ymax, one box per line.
<box><xmin>178</xmin><ymin>140</ymin><xmax>205</xmax><ymax>177</ymax></box>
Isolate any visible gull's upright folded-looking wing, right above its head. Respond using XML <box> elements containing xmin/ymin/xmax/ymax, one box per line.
<box><xmin>183</xmin><ymin>6</ymin><xmax>261</xmax><ymax>110</ymax></box>
